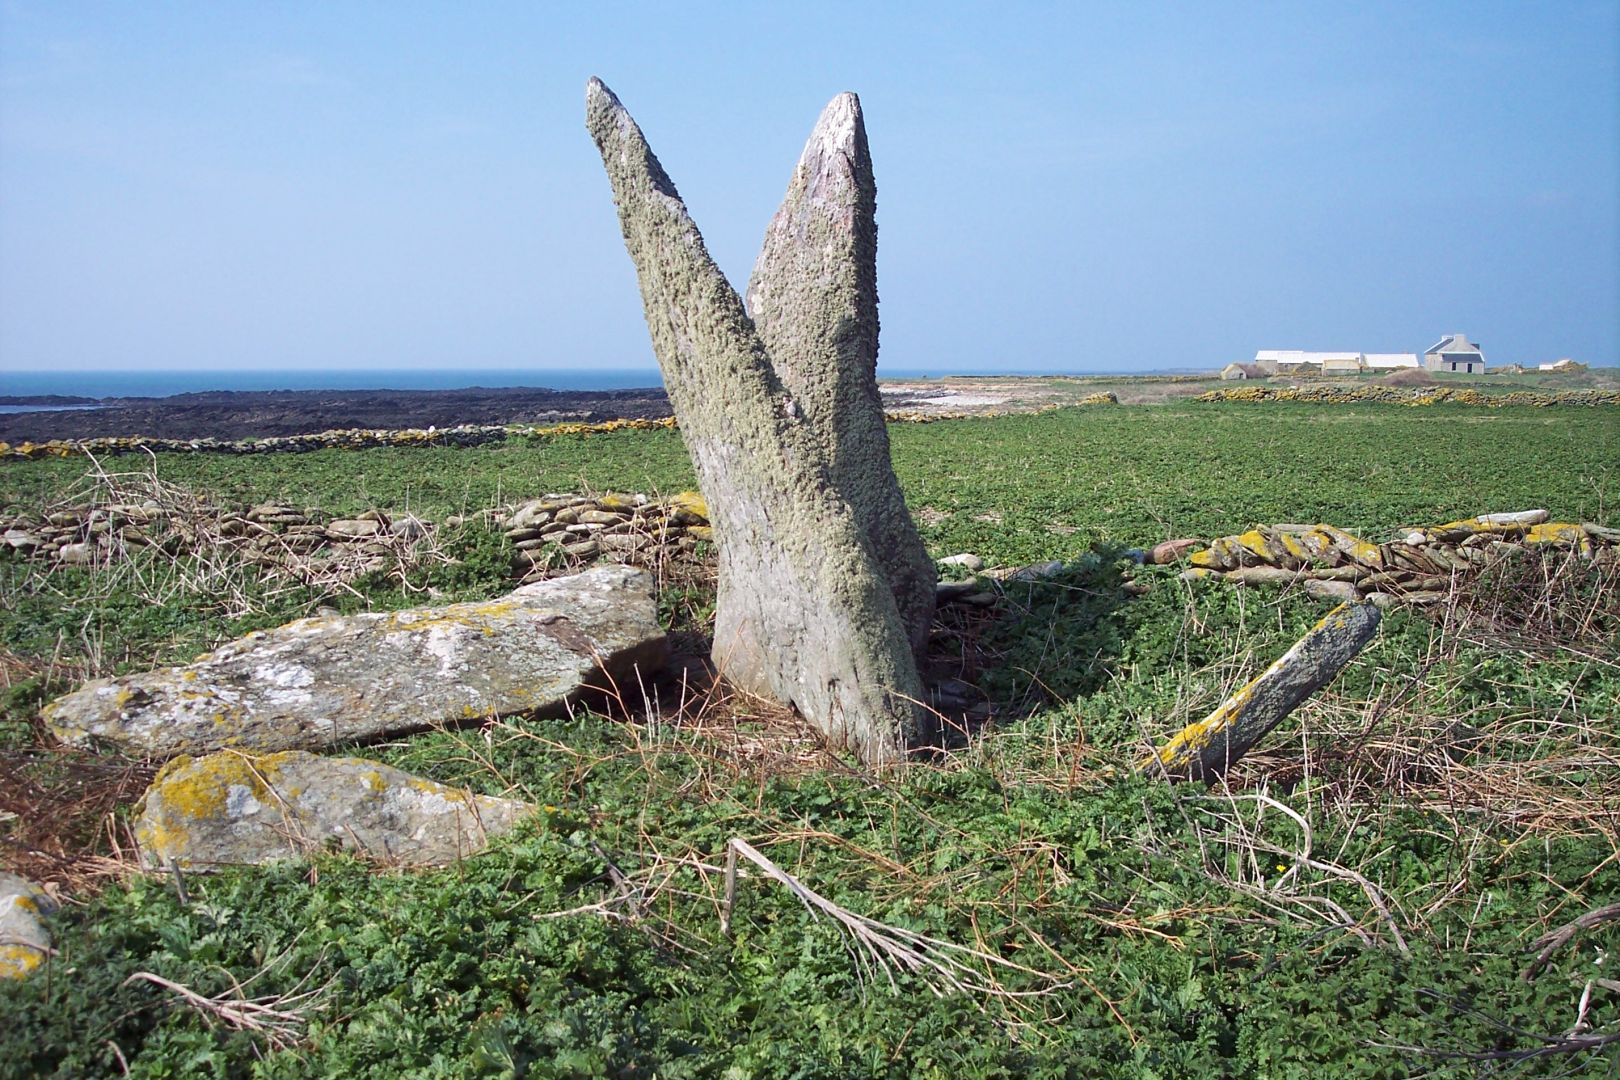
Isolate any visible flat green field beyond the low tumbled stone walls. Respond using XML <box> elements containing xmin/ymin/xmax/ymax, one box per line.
<box><xmin>0</xmin><ymin>403</ymin><xmax>1620</xmax><ymax>544</ymax></box>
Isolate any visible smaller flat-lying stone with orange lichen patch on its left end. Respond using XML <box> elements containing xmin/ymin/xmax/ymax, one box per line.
<box><xmin>134</xmin><ymin>750</ymin><xmax>538</xmax><ymax>870</ymax></box>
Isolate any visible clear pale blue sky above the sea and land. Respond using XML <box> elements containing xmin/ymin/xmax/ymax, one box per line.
<box><xmin>0</xmin><ymin>0</ymin><xmax>1620</xmax><ymax>378</ymax></box>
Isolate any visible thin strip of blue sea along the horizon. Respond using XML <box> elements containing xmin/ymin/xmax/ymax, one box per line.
<box><xmin>0</xmin><ymin>368</ymin><xmax>1179</xmax><ymax>400</ymax></box>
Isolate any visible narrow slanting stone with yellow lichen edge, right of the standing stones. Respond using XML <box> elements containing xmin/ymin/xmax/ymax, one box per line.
<box><xmin>1137</xmin><ymin>604</ymin><xmax>1380</xmax><ymax>780</ymax></box>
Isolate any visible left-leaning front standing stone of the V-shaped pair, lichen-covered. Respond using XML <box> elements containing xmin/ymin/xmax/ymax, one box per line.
<box><xmin>585</xmin><ymin>79</ymin><xmax>932</xmax><ymax>763</ymax></box>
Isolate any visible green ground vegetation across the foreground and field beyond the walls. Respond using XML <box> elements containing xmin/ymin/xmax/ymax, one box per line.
<box><xmin>0</xmin><ymin>403</ymin><xmax>1620</xmax><ymax>1078</ymax></box>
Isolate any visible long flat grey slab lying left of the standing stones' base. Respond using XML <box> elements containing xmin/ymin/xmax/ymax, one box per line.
<box><xmin>44</xmin><ymin>565</ymin><xmax>669</xmax><ymax>758</ymax></box>
